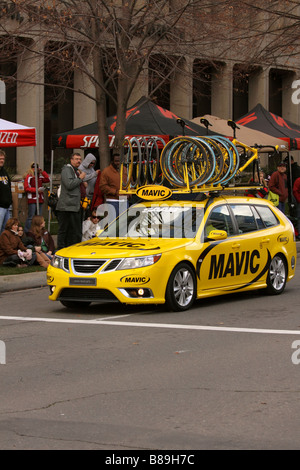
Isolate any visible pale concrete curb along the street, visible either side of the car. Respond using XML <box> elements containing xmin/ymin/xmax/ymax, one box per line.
<box><xmin>0</xmin><ymin>242</ymin><xmax>300</xmax><ymax>294</ymax></box>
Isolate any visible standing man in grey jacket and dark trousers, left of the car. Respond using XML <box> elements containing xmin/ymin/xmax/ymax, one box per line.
<box><xmin>56</xmin><ymin>153</ymin><xmax>87</xmax><ymax>250</ymax></box>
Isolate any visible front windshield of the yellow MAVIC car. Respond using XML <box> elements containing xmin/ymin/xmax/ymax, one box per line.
<box><xmin>99</xmin><ymin>204</ymin><xmax>204</xmax><ymax>238</ymax></box>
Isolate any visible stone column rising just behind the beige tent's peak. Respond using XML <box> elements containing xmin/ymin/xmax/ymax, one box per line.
<box><xmin>211</xmin><ymin>63</ymin><xmax>233</xmax><ymax>119</ymax></box>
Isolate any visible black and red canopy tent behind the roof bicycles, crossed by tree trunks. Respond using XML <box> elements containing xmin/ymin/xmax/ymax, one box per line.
<box><xmin>52</xmin><ymin>97</ymin><xmax>216</xmax><ymax>149</ymax></box>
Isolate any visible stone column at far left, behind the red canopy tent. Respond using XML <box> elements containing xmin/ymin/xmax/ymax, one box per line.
<box><xmin>17</xmin><ymin>41</ymin><xmax>44</xmax><ymax>175</ymax></box>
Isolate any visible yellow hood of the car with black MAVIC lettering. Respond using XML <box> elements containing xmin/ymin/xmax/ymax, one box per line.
<box><xmin>56</xmin><ymin>237</ymin><xmax>193</xmax><ymax>258</ymax></box>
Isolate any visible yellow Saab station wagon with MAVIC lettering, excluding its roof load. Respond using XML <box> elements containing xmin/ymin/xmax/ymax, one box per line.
<box><xmin>47</xmin><ymin>195</ymin><xmax>296</xmax><ymax>311</ymax></box>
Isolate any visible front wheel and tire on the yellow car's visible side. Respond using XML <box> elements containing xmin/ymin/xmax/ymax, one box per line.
<box><xmin>166</xmin><ymin>263</ymin><xmax>196</xmax><ymax>312</ymax></box>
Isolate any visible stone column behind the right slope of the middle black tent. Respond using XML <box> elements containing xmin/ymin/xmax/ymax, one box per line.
<box><xmin>170</xmin><ymin>57</ymin><xmax>193</xmax><ymax>120</ymax></box>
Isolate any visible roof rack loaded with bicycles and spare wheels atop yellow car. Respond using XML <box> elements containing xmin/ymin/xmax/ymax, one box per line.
<box><xmin>120</xmin><ymin>136</ymin><xmax>278</xmax><ymax>198</ymax></box>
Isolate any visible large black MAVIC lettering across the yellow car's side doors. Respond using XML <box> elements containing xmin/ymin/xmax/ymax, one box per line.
<box><xmin>208</xmin><ymin>250</ymin><xmax>260</xmax><ymax>279</ymax></box>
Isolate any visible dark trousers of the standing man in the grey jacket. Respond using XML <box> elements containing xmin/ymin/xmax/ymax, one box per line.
<box><xmin>56</xmin><ymin>211</ymin><xmax>82</xmax><ymax>250</ymax></box>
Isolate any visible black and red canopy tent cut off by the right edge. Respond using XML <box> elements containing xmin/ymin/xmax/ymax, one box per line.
<box><xmin>235</xmin><ymin>104</ymin><xmax>300</xmax><ymax>150</ymax></box>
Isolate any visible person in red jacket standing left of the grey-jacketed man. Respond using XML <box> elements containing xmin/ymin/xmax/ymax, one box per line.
<box><xmin>24</xmin><ymin>163</ymin><xmax>50</xmax><ymax>233</ymax></box>
